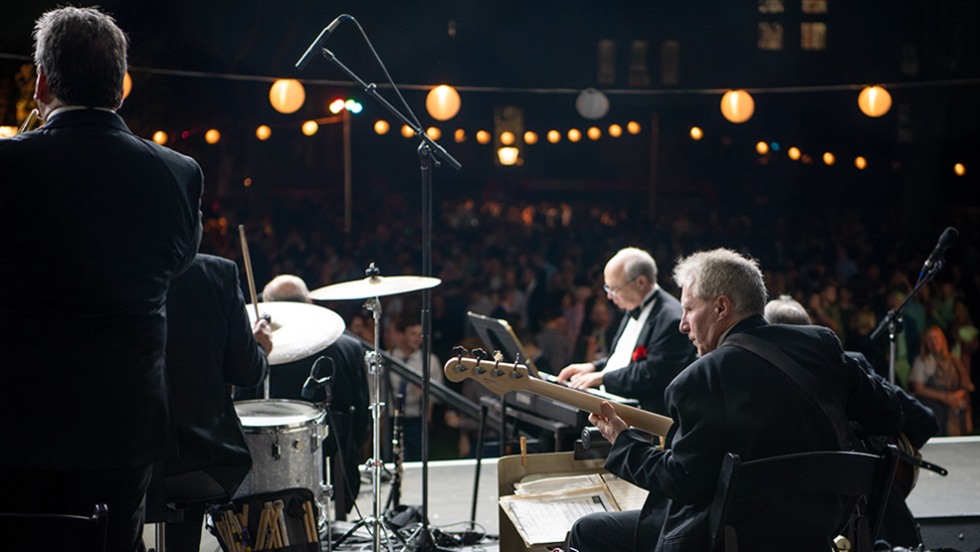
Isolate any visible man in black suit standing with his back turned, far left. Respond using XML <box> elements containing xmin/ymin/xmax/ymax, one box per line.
<box><xmin>0</xmin><ymin>7</ymin><xmax>203</xmax><ymax>551</ymax></box>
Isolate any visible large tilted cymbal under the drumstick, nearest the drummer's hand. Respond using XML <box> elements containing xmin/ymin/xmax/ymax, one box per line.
<box><xmin>246</xmin><ymin>301</ymin><xmax>346</xmax><ymax>366</ymax></box>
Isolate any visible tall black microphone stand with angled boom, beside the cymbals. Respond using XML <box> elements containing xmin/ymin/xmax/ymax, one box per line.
<box><xmin>322</xmin><ymin>48</ymin><xmax>462</xmax><ymax>551</ymax></box>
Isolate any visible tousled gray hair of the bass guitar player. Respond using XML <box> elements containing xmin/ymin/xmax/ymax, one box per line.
<box><xmin>674</xmin><ymin>249</ymin><xmax>766</xmax><ymax>314</ymax></box>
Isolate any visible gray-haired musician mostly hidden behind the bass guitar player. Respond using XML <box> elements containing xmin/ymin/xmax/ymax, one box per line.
<box><xmin>765</xmin><ymin>295</ymin><xmax>939</xmax><ymax>548</ymax></box>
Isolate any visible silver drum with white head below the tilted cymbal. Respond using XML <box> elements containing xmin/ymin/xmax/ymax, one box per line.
<box><xmin>234</xmin><ymin>399</ymin><xmax>327</xmax><ymax>505</ymax></box>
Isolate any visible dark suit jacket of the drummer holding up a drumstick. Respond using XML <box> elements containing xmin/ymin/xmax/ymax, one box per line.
<box><xmin>166</xmin><ymin>255</ymin><xmax>275</xmax><ymax>496</ymax></box>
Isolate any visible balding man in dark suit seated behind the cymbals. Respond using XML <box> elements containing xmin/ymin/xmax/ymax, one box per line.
<box><xmin>260</xmin><ymin>274</ymin><xmax>370</xmax><ymax>520</ymax></box>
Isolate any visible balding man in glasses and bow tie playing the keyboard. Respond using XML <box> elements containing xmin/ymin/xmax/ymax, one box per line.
<box><xmin>558</xmin><ymin>247</ymin><xmax>697</xmax><ymax>415</ymax></box>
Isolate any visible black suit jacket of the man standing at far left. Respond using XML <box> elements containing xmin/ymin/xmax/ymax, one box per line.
<box><xmin>0</xmin><ymin>109</ymin><xmax>203</xmax><ymax>469</ymax></box>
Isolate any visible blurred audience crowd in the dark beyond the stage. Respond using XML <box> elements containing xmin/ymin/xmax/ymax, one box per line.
<box><xmin>195</xmin><ymin>192</ymin><xmax>980</xmax><ymax>450</ymax></box>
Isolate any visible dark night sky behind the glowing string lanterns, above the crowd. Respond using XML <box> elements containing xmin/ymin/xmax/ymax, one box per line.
<box><xmin>0</xmin><ymin>0</ymin><xmax>980</xmax><ymax>232</ymax></box>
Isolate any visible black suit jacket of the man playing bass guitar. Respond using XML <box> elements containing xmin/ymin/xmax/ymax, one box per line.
<box><xmin>606</xmin><ymin>316</ymin><xmax>903</xmax><ymax>551</ymax></box>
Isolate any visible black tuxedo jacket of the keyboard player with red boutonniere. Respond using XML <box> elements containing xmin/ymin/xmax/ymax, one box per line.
<box><xmin>595</xmin><ymin>288</ymin><xmax>697</xmax><ymax>415</ymax></box>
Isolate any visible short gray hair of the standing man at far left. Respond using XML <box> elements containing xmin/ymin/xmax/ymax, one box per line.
<box><xmin>34</xmin><ymin>6</ymin><xmax>129</xmax><ymax>109</ymax></box>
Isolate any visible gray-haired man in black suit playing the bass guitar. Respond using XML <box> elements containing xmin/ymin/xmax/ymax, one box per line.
<box><xmin>569</xmin><ymin>249</ymin><xmax>903</xmax><ymax>552</ymax></box>
